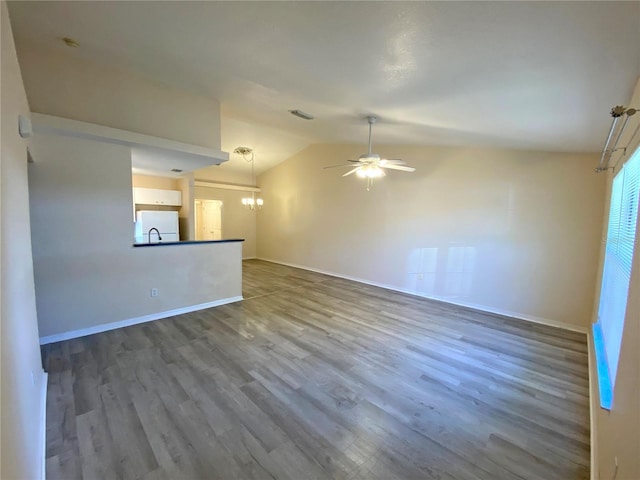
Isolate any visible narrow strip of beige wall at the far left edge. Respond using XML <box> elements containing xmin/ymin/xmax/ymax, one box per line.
<box><xmin>0</xmin><ymin>2</ymin><xmax>46</xmax><ymax>480</ymax></box>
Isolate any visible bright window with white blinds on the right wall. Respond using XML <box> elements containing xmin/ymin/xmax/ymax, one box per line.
<box><xmin>593</xmin><ymin>149</ymin><xmax>640</xmax><ymax>409</ymax></box>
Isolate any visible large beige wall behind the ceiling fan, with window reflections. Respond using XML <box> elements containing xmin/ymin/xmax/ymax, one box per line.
<box><xmin>257</xmin><ymin>145</ymin><xmax>605</xmax><ymax>328</ymax></box>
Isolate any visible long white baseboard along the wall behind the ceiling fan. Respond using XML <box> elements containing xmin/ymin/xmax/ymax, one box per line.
<box><xmin>258</xmin><ymin>257</ymin><xmax>589</xmax><ymax>334</ymax></box>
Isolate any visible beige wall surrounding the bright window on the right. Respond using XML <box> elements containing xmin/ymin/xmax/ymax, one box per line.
<box><xmin>592</xmin><ymin>79</ymin><xmax>640</xmax><ymax>480</ymax></box>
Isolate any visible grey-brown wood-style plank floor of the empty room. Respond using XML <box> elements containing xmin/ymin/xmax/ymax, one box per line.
<box><xmin>43</xmin><ymin>260</ymin><xmax>589</xmax><ymax>480</ymax></box>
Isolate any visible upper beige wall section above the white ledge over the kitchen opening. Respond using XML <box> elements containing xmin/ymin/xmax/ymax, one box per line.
<box><xmin>18</xmin><ymin>43</ymin><xmax>220</xmax><ymax>150</ymax></box>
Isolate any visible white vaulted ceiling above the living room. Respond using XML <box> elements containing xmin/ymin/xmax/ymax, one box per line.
<box><xmin>10</xmin><ymin>1</ymin><xmax>640</xmax><ymax>170</ymax></box>
